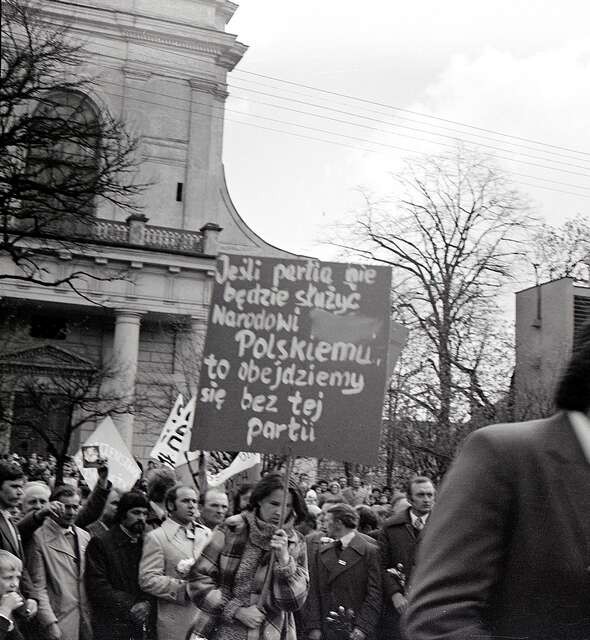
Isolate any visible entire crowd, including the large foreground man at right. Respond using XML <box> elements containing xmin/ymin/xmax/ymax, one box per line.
<box><xmin>0</xmin><ymin>325</ymin><xmax>590</xmax><ymax>640</ymax></box>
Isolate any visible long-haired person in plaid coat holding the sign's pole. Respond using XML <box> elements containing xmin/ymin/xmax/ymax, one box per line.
<box><xmin>189</xmin><ymin>473</ymin><xmax>309</xmax><ymax>640</ymax></box>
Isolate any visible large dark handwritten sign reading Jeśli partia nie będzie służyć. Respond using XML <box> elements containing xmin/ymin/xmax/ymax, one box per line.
<box><xmin>191</xmin><ymin>255</ymin><xmax>399</xmax><ymax>464</ymax></box>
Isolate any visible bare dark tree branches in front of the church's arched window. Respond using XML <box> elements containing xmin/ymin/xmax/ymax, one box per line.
<box><xmin>0</xmin><ymin>0</ymin><xmax>145</xmax><ymax>288</ymax></box>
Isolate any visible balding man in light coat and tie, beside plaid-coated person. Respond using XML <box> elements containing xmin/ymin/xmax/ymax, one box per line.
<box><xmin>139</xmin><ymin>485</ymin><xmax>211</xmax><ymax>640</ymax></box>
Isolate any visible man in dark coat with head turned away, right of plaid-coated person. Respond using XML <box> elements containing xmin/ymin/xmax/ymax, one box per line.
<box><xmin>302</xmin><ymin>504</ymin><xmax>382</xmax><ymax>640</ymax></box>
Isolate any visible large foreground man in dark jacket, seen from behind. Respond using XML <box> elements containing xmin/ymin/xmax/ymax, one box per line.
<box><xmin>406</xmin><ymin>323</ymin><xmax>590</xmax><ymax>640</ymax></box>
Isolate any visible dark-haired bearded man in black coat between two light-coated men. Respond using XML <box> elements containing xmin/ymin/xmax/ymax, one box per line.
<box><xmin>85</xmin><ymin>491</ymin><xmax>155</xmax><ymax>640</ymax></box>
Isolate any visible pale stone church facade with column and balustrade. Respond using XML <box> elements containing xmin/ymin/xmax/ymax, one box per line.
<box><xmin>0</xmin><ymin>0</ymin><xmax>292</xmax><ymax>460</ymax></box>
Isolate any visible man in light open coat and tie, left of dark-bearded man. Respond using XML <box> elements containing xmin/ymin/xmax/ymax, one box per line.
<box><xmin>28</xmin><ymin>485</ymin><xmax>92</xmax><ymax>640</ymax></box>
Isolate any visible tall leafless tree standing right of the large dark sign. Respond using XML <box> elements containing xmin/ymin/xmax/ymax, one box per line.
<box><xmin>335</xmin><ymin>148</ymin><xmax>533</xmax><ymax>476</ymax></box>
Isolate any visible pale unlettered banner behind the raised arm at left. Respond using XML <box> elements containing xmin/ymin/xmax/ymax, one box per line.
<box><xmin>74</xmin><ymin>416</ymin><xmax>141</xmax><ymax>491</ymax></box>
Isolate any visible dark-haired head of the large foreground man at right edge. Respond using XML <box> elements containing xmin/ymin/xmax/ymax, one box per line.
<box><xmin>555</xmin><ymin>320</ymin><xmax>590</xmax><ymax>413</ymax></box>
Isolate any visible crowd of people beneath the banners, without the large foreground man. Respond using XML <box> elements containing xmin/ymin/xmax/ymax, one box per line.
<box><xmin>0</xmin><ymin>444</ymin><xmax>434</xmax><ymax>640</ymax></box>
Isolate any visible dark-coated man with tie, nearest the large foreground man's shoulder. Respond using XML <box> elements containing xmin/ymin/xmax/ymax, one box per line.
<box><xmin>377</xmin><ymin>476</ymin><xmax>435</xmax><ymax>640</ymax></box>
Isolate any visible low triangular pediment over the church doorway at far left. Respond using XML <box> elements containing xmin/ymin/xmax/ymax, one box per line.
<box><xmin>0</xmin><ymin>344</ymin><xmax>96</xmax><ymax>373</ymax></box>
